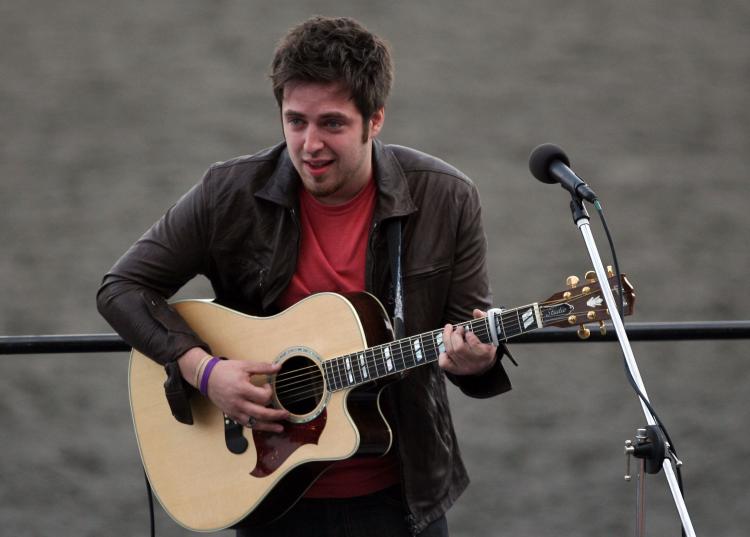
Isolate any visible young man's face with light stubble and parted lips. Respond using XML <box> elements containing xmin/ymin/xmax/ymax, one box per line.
<box><xmin>281</xmin><ymin>82</ymin><xmax>384</xmax><ymax>205</ymax></box>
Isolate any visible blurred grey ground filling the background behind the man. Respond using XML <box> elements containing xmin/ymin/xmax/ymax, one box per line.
<box><xmin>0</xmin><ymin>0</ymin><xmax>750</xmax><ymax>537</ymax></box>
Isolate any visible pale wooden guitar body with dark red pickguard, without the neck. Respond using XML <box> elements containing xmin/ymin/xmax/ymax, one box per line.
<box><xmin>129</xmin><ymin>293</ymin><xmax>392</xmax><ymax>531</ymax></box>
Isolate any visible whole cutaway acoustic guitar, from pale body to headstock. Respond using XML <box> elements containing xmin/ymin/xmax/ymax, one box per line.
<box><xmin>129</xmin><ymin>276</ymin><xmax>635</xmax><ymax>532</ymax></box>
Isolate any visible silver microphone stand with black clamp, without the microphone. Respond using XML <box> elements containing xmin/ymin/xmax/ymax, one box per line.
<box><xmin>570</xmin><ymin>195</ymin><xmax>695</xmax><ymax>537</ymax></box>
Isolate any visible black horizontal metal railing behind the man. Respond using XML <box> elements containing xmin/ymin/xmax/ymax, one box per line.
<box><xmin>0</xmin><ymin>321</ymin><xmax>750</xmax><ymax>354</ymax></box>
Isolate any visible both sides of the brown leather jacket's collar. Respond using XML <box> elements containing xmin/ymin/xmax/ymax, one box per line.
<box><xmin>255</xmin><ymin>140</ymin><xmax>417</xmax><ymax>220</ymax></box>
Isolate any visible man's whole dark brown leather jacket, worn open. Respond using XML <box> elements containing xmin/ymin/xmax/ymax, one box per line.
<box><xmin>97</xmin><ymin>141</ymin><xmax>510</xmax><ymax>533</ymax></box>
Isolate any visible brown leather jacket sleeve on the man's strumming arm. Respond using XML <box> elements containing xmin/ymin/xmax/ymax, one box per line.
<box><xmin>97</xmin><ymin>172</ymin><xmax>210</xmax><ymax>364</ymax></box>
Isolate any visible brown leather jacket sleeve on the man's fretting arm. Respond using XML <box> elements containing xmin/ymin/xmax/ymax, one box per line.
<box><xmin>445</xmin><ymin>183</ymin><xmax>511</xmax><ymax>398</ymax></box>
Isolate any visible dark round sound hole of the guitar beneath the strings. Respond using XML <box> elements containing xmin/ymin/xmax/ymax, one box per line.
<box><xmin>276</xmin><ymin>356</ymin><xmax>324</xmax><ymax>416</ymax></box>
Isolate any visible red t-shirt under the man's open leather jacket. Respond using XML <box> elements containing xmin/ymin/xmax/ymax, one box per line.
<box><xmin>278</xmin><ymin>180</ymin><xmax>400</xmax><ymax>498</ymax></box>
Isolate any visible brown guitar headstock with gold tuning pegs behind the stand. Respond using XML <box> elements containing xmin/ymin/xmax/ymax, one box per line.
<box><xmin>539</xmin><ymin>267</ymin><xmax>635</xmax><ymax>339</ymax></box>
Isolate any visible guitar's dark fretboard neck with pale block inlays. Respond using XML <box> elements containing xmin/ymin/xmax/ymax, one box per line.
<box><xmin>324</xmin><ymin>303</ymin><xmax>544</xmax><ymax>391</ymax></box>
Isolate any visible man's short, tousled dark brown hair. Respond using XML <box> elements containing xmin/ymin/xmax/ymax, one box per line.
<box><xmin>271</xmin><ymin>17</ymin><xmax>393</xmax><ymax>120</ymax></box>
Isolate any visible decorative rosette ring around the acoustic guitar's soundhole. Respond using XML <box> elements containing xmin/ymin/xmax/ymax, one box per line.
<box><xmin>272</xmin><ymin>347</ymin><xmax>329</xmax><ymax>423</ymax></box>
